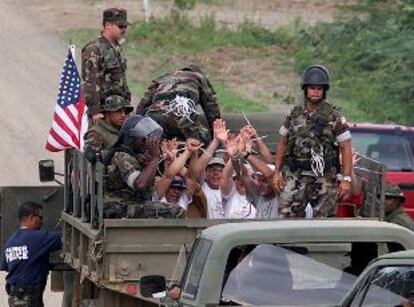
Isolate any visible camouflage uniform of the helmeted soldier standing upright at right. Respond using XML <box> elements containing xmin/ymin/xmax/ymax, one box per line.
<box><xmin>279</xmin><ymin>101</ymin><xmax>351</xmax><ymax>217</ymax></box>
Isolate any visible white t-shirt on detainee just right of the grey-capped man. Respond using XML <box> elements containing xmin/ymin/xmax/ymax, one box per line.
<box><xmin>222</xmin><ymin>182</ymin><xmax>256</xmax><ymax>219</ymax></box>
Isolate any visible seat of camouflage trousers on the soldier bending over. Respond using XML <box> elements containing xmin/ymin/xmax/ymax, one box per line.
<box><xmin>147</xmin><ymin>111</ymin><xmax>211</xmax><ymax>146</ymax></box>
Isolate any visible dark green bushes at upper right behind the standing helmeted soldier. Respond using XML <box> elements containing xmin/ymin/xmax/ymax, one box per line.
<box><xmin>296</xmin><ymin>0</ymin><xmax>414</xmax><ymax>125</ymax></box>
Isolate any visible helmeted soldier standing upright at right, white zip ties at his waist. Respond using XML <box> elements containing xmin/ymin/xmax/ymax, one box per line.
<box><xmin>273</xmin><ymin>65</ymin><xmax>352</xmax><ymax>217</ymax></box>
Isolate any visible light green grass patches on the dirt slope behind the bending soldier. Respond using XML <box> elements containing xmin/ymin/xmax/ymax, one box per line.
<box><xmin>64</xmin><ymin>14</ymin><xmax>292</xmax><ymax>112</ymax></box>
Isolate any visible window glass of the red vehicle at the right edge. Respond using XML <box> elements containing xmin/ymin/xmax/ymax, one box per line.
<box><xmin>351</xmin><ymin>130</ymin><xmax>414</xmax><ymax>172</ymax></box>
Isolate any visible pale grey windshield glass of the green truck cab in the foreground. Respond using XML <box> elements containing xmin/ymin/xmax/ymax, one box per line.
<box><xmin>222</xmin><ymin>244</ymin><xmax>356</xmax><ymax>306</ymax></box>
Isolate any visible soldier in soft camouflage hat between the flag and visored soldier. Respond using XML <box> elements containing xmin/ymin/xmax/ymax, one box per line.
<box><xmin>85</xmin><ymin>95</ymin><xmax>134</xmax><ymax>163</ymax></box>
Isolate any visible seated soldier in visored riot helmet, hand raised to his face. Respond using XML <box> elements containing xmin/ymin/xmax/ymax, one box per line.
<box><xmin>103</xmin><ymin>115</ymin><xmax>185</xmax><ymax>218</ymax></box>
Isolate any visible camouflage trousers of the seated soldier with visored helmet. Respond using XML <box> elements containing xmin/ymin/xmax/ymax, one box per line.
<box><xmin>104</xmin><ymin>201</ymin><xmax>185</xmax><ymax>219</ymax></box>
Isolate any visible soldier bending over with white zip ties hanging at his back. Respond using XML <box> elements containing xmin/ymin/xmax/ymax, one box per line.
<box><xmin>136</xmin><ymin>65</ymin><xmax>221</xmax><ymax>146</ymax></box>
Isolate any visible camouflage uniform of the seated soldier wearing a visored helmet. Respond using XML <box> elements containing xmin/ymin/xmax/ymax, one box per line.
<box><xmin>104</xmin><ymin>145</ymin><xmax>185</xmax><ymax>218</ymax></box>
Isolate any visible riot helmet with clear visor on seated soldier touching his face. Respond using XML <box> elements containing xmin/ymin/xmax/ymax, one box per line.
<box><xmin>121</xmin><ymin>115</ymin><xmax>163</xmax><ymax>138</ymax></box>
